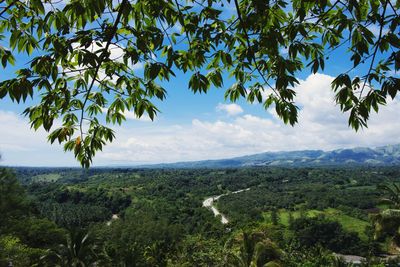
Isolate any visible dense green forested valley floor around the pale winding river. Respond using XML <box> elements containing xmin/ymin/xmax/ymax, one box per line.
<box><xmin>0</xmin><ymin>167</ymin><xmax>400</xmax><ymax>266</ymax></box>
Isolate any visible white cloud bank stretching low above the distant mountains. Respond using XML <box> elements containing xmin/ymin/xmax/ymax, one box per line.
<box><xmin>0</xmin><ymin>74</ymin><xmax>400</xmax><ymax>165</ymax></box>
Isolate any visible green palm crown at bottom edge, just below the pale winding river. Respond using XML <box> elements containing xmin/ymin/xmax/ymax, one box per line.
<box><xmin>225</xmin><ymin>232</ymin><xmax>283</xmax><ymax>267</ymax></box>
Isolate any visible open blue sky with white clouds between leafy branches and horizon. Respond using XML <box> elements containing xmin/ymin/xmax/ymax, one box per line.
<box><xmin>0</xmin><ymin>2</ymin><xmax>400</xmax><ymax>167</ymax></box>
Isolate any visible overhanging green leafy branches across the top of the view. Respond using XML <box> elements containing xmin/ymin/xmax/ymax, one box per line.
<box><xmin>0</xmin><ymin>0</ymin><xmax>400</xmax><ymax>167</ymax></box>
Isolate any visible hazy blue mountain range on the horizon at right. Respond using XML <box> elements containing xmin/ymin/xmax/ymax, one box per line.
<box><xmin>143</xmin><ymin>144</ymin><xmax>400</xmax><ymax>168</ymax></box>
